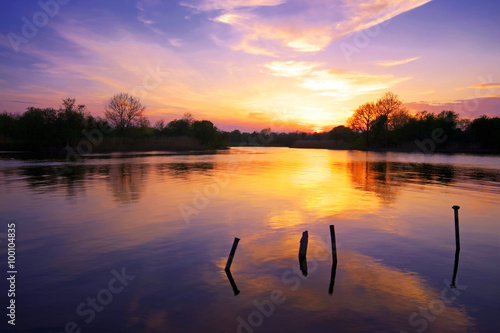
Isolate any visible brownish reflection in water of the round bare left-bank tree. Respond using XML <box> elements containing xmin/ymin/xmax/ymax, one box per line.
<box><xmin>109</xmin><ymin>163</ymin><xmax>150</xmax><ymax>203</ymax></box>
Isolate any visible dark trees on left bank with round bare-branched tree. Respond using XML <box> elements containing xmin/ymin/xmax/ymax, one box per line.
<box><xmin>0</xmin><ymin>93</ymin><xmax>228</xmax><ymax>152</ymax></box>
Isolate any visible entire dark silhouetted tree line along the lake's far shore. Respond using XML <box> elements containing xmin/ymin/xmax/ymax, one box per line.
<box><xmin>0</xmin><ymin>92</ymin><xmax>500</xmax><ymax>152</ymax></box>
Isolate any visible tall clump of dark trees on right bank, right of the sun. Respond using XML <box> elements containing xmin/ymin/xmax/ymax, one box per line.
<box><xmin>344</xmin><ymin>92</ymin><xmax>500</xmax><ymax>152</ymax></box>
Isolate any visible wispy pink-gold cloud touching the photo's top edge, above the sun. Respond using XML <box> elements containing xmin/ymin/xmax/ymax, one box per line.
<box><xmin>188</xmin><ymin>0</ymin><xmax>431</xmax><ymax>56</ymax></box>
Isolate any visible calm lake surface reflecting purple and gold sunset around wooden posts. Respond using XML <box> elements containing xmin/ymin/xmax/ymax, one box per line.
<box><xmin>0</xmin><ymin>148</ymin><xmax>500</xmax><ymax>333</ymax></box>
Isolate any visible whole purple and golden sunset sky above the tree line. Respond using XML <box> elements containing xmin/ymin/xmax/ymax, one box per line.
<box><xmin>0</xmin><ymin>0</ymin><xmax>500</xmax><ymax>131</ymax></box>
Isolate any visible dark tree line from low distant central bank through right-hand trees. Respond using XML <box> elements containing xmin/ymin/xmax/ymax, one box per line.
<box><xmin>230</xmin><ymin>92</ymin><xmax>500</xmax><ymax>153</ymax></box>
